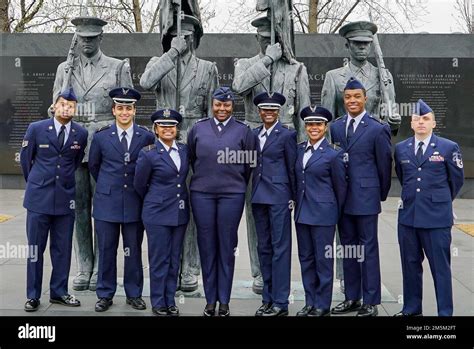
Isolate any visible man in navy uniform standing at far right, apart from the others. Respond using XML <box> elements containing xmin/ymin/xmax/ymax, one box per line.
<box><xmin>395</xmin><ymin>99</ymin><xmax>464</xmax><ymax>316</ymax></box>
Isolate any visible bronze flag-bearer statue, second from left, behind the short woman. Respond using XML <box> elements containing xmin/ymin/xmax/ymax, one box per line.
<box><xmin>140</xmin><ymin>0</ymin><xmax>218</xmax><ymax>292</ymax></box>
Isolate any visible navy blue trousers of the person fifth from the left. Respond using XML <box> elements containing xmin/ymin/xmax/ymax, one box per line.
<box><xmin>252</xmin><ymin>204</ymin><xmax>291</xmax><ymax>309</ymax></box>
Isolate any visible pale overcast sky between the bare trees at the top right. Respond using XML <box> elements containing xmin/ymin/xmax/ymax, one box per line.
<box><xmin>203</xmin><ymin>0</ymin><xmax>472</xmax><ymax>33</ymax></box>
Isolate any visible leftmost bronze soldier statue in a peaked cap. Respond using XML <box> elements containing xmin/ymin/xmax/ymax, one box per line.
<box><xmin>53</xmin><ymin>17</ymin><xmax>133</xmax><ymax>291</ymax></box>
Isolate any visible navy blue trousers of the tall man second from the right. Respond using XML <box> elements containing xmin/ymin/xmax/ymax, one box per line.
<box><xmin>339</xmin><ymin>214</ymin><xmax>382</xmax><ymax>305</ymax></box>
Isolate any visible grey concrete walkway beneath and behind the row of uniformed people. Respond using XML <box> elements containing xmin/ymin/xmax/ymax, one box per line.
<box><xmin>0</xmin><ymin>189</ymin><xmax>474</xmax><ymax>316</ymax></box>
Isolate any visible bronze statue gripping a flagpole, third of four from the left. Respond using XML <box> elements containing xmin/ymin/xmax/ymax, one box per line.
<box><xmin>232</xmin><ymin>0</ymin><xmax>310</xmax><ymax>293</ymax></box>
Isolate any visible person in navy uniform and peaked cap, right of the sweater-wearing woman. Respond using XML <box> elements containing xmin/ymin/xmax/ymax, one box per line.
<box><xmin>251</xmin><ymin>92</ymin><xmax>296</xmax><ymax>316</ymax></box>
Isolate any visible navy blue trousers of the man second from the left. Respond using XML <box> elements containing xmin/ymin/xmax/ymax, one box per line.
<box><xmin>94</xmin><ymin>219</ymin><xmax>143</xmax><ymax>298</ymax></box>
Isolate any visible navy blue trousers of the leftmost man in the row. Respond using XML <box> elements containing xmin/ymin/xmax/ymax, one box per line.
<box><xmin>26</xmin><ymin>210</ymin><xmax>74</xmax><ymax>298</ymax></box>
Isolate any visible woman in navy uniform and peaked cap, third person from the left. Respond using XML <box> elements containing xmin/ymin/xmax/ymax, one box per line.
<box><xmin>134</xmin><ymin>109</ymin><xmax>189</xmax><ymax>316</ymax></box>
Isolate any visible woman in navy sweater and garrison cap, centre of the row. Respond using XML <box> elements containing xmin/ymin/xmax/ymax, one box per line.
<box><xmin>188</xmin><ymin>87</ymin><xmax>256</xmax><ymax>316</ymax></box>
